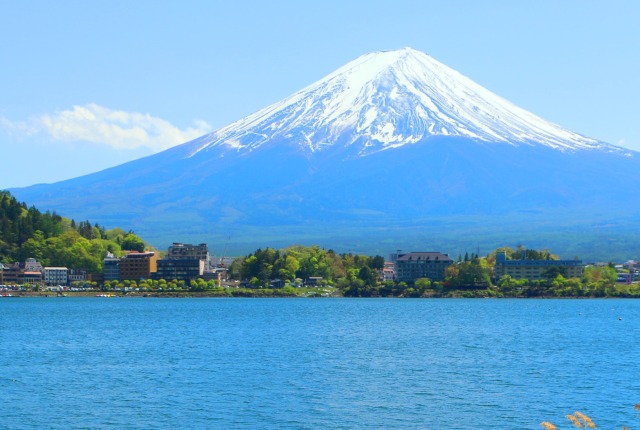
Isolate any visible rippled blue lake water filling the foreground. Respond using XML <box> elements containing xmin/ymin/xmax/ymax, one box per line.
<box><xmin>0</xmin><ymin>298</ymin><xmax>640</xmax><ymax>429</ymax></box>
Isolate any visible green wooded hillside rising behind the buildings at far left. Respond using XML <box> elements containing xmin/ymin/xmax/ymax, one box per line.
<box><xmin>0</xmin><ymin>191</ymin><xmax>145</xmax><ymax>273</ymax></box>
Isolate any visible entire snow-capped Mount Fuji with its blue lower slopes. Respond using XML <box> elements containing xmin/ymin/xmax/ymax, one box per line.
<box><xmin>12</xmin><ymin>48</ymin><xmax>640</xmax><ymax>255</ymax></box>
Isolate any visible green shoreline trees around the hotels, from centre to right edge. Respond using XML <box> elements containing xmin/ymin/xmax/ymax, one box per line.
<box><xmin>229</xmin><ymin>246</ymin><xmax>640</xmax><ymax>297</ymax></box>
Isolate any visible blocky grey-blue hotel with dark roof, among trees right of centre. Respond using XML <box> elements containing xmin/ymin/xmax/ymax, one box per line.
<box><xmin>394</xmin><ymin>252</ymin><xmax>453</xmax><ymax>283</ymax></box>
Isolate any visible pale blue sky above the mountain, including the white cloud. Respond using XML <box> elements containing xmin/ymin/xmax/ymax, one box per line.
<box><xmin>0</xmin><ymin>0</ymin><xmax>640</xmax><ymax>189</ymax></box>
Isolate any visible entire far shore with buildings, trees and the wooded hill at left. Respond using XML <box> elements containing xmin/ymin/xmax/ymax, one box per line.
<box><xmin>0</xmin><ymin>191</ymin><xmax>640</xmax><ymax>297</ymax></box>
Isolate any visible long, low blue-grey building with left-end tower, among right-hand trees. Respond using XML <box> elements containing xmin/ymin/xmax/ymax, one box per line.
<box><xmin>494</xmin><ymin>252</ymin><xmax>584</xmax><ymax>281</ymax></box>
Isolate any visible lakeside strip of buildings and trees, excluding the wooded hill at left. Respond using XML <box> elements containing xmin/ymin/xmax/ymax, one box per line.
<box><xmin>0</xmin><ymin>242</ymin><xmax>640</xmax><ymax>297</ymax></box>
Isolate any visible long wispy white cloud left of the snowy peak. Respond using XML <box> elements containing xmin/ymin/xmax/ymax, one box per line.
<box><xmin>0</xmin><ymin>103</ymin><xmax>211</xmax><ymax>151</ymax></box>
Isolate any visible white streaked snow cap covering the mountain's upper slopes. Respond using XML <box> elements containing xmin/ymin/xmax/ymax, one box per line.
<box><xmin>189</xmin><ymin>48</ymin><xmax>628</xmax><ymax>156</ymax></box>
